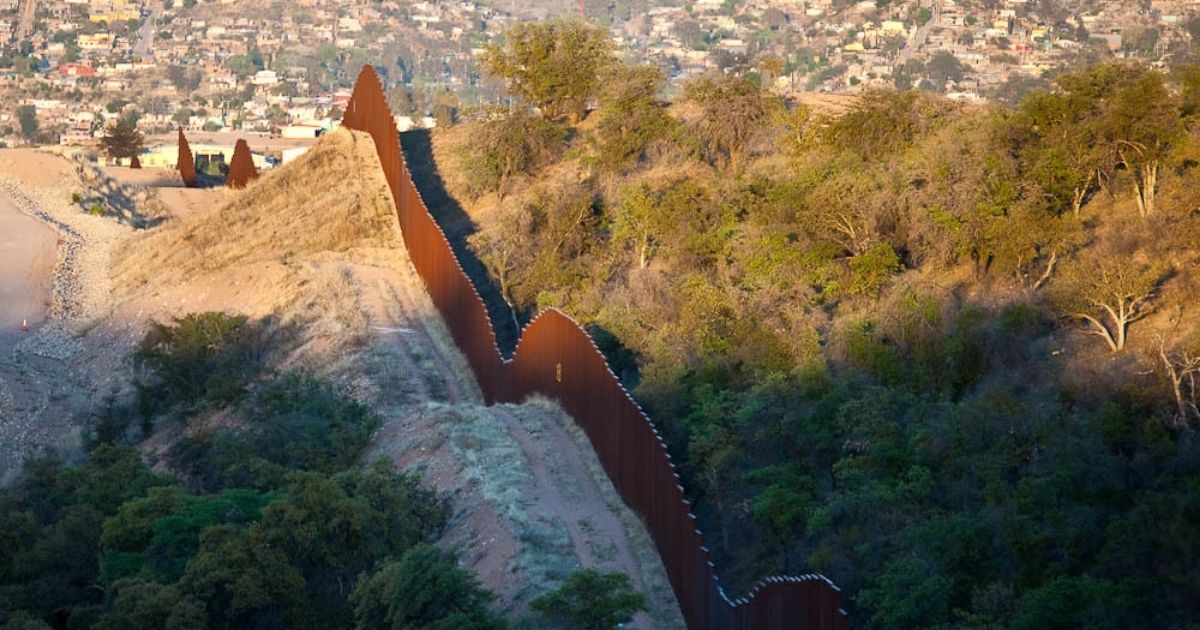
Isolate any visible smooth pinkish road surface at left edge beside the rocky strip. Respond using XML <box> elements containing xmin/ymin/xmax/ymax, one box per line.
<box><xmin>0</xmin><ymin>197</ymin><xmax>58</xmax><ymax>354</ymax></box>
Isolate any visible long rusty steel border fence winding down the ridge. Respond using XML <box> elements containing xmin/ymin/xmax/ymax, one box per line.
<box><xmin>342</xmin><ymin>66</ymin><xmax>848</xmax><ymax>630</ymax></box>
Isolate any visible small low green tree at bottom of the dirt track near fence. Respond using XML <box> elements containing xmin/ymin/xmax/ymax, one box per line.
<box><xmin>529</xmin><ymin>569</ymin><xmax>646</xmax><ymax>630</ymax></box>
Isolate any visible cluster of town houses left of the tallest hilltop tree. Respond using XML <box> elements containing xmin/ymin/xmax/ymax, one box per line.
<box><xmin>0</xmin><ymin>0</ymin><xmax>501</xmax><ymax>144</ymax></box>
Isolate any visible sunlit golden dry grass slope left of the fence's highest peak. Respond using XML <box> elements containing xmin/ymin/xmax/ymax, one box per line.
<box><xmin>113</xmin><ymin>130</ymin><xmax>398</xmax><ymax>292</ymax></box>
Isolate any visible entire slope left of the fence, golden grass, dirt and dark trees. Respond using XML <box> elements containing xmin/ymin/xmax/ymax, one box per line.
<box><xmin>0</xmin><ymin>121</ymin><xmax>682</xmax><ymax>630</ymax></box>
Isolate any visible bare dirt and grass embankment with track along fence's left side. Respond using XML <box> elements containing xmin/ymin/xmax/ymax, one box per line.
<box><xmin>0</xmin><ymin>131</ymin><xmax>683</xmax><ymax>628</ymax></box>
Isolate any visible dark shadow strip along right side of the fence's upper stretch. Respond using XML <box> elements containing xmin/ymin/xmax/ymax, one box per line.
<box><xmin>400</xmin><ymin>130</ymin><xmax>527</xmax><ymax>358</ymax></box>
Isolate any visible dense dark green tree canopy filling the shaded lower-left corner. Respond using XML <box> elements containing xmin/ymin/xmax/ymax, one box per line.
<box><xmin>0</xmin><ymin>313</ymin><xmax>503</xmax><ymax>630</ymax></box>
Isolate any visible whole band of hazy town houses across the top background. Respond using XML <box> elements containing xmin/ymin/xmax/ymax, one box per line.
<box><xmin>0</xmin><ymin>0</ymin><xmax>1200</xmax><ymax>150</ymax></box>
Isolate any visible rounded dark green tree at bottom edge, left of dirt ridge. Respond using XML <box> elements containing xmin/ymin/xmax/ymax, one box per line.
<box><xmin>350</xmin><ymin>545</ymin><xmax>504</xmax><ymax>630</ymax></box>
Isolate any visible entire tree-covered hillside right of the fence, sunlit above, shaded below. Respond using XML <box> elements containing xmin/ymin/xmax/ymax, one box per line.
<box><xmin>434</xmin><ymin>23</ymin><xmax>1200</xmax><ymax>628</ymax></box>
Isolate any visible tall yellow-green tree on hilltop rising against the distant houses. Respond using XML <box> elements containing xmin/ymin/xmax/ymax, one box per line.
<box><xmin>482</xmin><ymin>19</ymin><xmax>614</xmax><ymax>121</ymax></box>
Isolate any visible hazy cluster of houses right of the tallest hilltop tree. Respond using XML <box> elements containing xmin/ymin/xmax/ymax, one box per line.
<box><xmin>623</xmin><ymin>0</ymin><xmax>1200</xmax><ymax>100</ymax></box>
